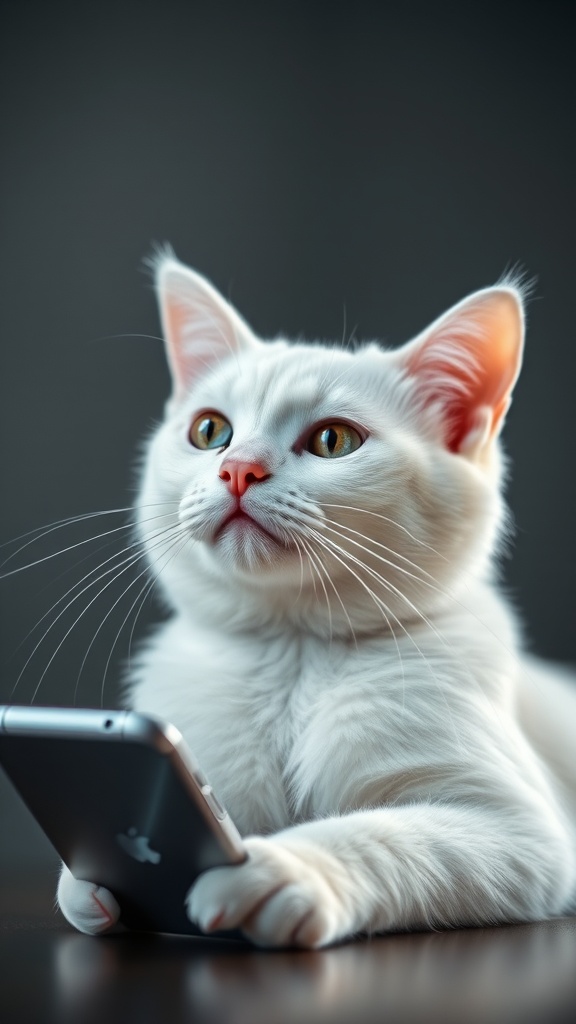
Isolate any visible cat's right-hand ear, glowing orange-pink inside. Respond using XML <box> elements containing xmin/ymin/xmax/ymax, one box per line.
<box><xmin>399</xmin><ymin>284</ymin><xmax>524</xmax><ymax>459</ymax></box>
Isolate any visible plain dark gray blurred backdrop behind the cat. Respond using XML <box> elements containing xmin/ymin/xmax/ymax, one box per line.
<box><xmin>0</xmin><ymin>0</ymin><xmax>576</xmax><ymax>857</ymax></box>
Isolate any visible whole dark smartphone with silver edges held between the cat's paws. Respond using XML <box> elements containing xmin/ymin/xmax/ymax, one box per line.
<box><xmin>0</xmin><ymin>706</ymin><xmax>246</xmax><ymax>935</ymax></box>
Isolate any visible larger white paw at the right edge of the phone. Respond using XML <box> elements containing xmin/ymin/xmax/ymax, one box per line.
<box><xmin>187</xmin><ymin>838</ymin><xmax>347</xmax><ymax>948</ymax></box>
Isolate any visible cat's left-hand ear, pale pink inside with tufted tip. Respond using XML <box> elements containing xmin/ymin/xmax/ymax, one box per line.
<box><xmin>154</xmin><ymin>253</ymin><xmax>254</xmax><ymax>398</ymax></box>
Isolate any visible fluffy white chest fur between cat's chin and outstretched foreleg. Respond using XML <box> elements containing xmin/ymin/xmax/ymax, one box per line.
<box><xmin>133</xmin><ymin>624</ymin><xmax>444</xmax><ymax>834</ymax></box>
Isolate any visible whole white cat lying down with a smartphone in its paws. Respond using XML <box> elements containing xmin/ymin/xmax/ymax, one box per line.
<box><xmin>58</xmin><ymin>253</ymin><xmax>576</xmax><ymax>947</ymax></box>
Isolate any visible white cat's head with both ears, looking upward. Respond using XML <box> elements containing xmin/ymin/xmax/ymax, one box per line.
<box><xmin>139</xmin><ymin>253</ymin><xmax>524</xmax><ymax>635</ymax></box>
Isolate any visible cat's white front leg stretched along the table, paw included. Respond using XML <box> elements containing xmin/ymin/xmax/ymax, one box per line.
<box><xmin>187</xmin><ymin>804</ymin><xmax>576</xmax><ymax>948</ymax></box>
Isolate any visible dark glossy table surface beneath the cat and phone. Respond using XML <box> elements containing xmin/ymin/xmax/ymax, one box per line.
<box><xmin>0</xmin><ymin>877</ymin><xmax>576</xmax><ymax>1024</ymax></box>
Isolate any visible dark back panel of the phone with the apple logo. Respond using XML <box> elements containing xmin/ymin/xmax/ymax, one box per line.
<box><xmin>0</xmin><ymin>712</ymin><xmax>240</xmax><ymax>934</ymax></box>
